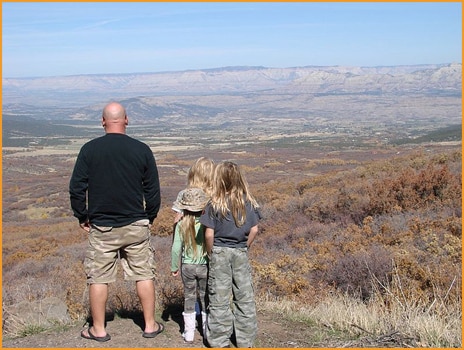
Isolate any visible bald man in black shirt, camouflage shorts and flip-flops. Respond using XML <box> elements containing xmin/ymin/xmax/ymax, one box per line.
<box><xmin>69</xmin><ymin>102</ymin><xmax>164</xmax><ymax>342</ymax></box>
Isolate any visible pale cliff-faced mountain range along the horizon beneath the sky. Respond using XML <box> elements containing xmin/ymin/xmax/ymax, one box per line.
<box><xmin>2</xmin><ymin>63</ymin><xmax>462</xmax><ymax>107</ymax></box>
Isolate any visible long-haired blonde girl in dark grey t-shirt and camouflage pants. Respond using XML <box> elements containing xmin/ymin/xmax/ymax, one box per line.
<box><xmin>200</xmin><ymin>162</ymin><xmax>261</xmax><ymax>348</ymax></box>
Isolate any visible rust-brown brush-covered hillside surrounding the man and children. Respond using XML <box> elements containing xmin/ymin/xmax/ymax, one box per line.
<box><xmin>2</xmin><ymin>139</ymin><xmax>462</xmax><ymax>347</ymax></box>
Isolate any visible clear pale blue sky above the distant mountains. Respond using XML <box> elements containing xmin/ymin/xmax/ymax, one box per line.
<box><xmin>2</xmin><ymin>2</ymin><xmax>462</xmax><ymax>77</ymax></box>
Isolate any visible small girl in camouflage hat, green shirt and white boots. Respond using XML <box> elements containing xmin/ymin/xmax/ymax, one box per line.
<box><xmin>171</xmin><ymin>188</ymin><xmax>209</xmax><ymax>342</ymax></box>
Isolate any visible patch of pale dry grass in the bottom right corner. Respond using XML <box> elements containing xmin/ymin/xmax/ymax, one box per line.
<box><xmin>259</xmin><ymin>268</ymin><xmax>462</xmax><ymax>348</ymax></box>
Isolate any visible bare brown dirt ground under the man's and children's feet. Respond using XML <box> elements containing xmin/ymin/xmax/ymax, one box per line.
<box><xmin>3</xmin><ymin>312</ymin><xmax>318</xmax><ymax>348</ymax></box>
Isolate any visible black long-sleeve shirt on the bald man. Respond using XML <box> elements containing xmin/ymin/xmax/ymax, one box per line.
<box><xmin>69</xmin><ymin>133</ymin><xmax>161</xmax><ymax>227</ymax></box>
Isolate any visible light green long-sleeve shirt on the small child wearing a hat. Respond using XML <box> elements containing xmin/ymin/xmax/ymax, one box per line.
<box><xmin>171</xmin><ymin>217</ymin><xmax>208</xmax><ymax>272</ymax></box>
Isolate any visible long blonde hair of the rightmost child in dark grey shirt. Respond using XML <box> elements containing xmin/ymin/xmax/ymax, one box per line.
<box><xmin>212</xmin><ymin>161</ymin><xmax>259</xmax><ymax>227</ymax></box>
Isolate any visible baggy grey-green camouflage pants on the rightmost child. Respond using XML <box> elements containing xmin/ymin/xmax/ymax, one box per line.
<box><xmin>207</xmin><ymin>247</ymin><xmax>258</xmax><ymax>348</ymax></box>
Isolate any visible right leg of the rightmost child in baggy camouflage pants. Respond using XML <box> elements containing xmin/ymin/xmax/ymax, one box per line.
<box><xmin>232</xmin><ymin>248</ymin><xmax>258</xmax><ymax>348</ymax></box>
